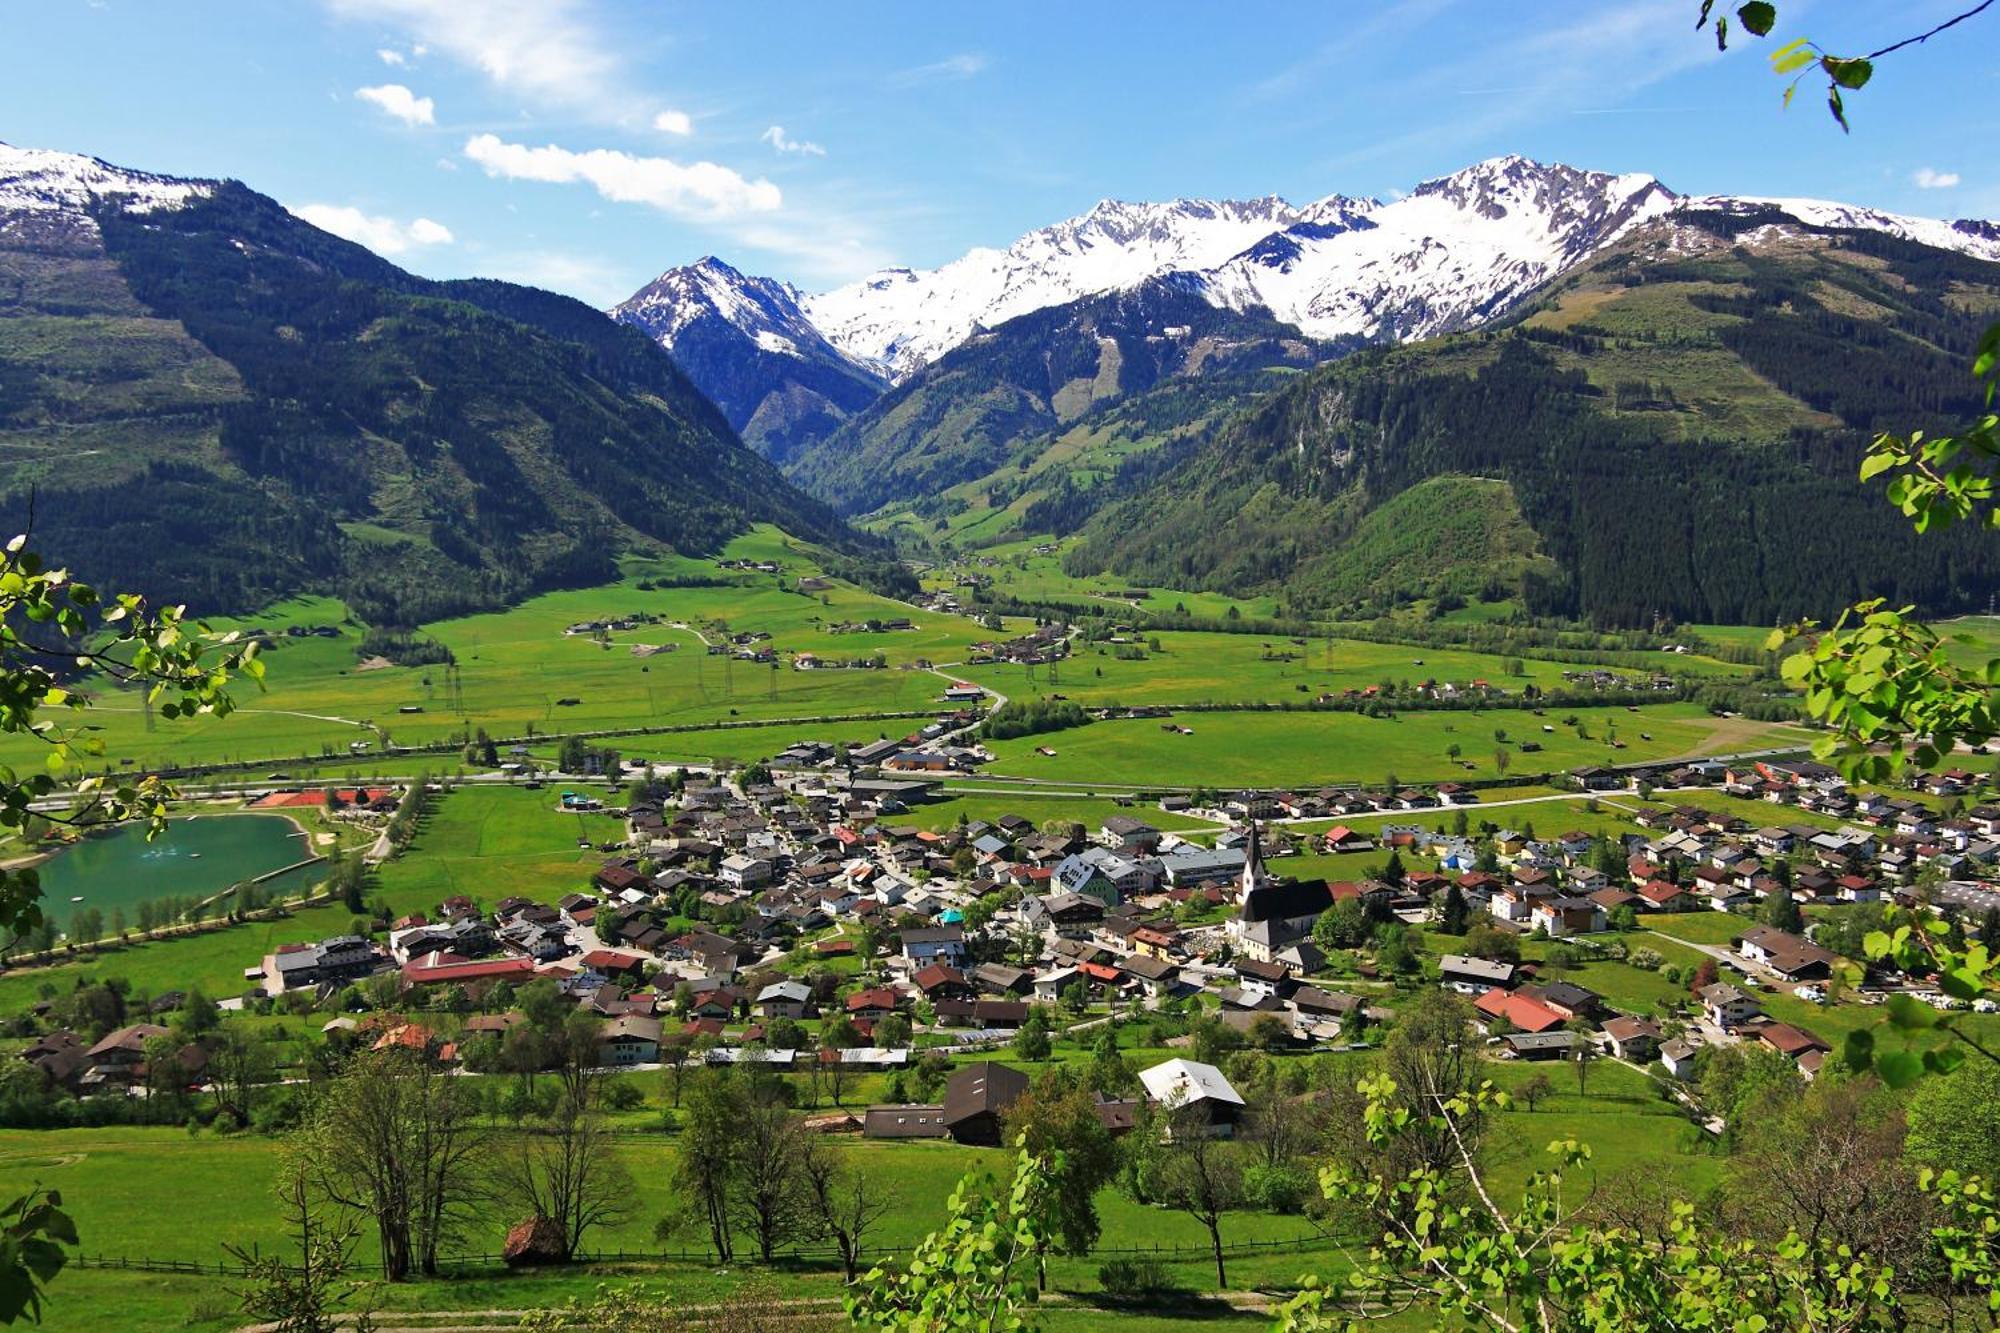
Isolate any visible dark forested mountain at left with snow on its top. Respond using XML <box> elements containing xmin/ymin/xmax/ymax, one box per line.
<box><xmin>0</xmin><ymin>150</ymin><xmax>860</xmax><ymax>624</ymax></box>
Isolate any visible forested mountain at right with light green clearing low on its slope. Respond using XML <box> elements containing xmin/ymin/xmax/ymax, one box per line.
<box><xmin>1070</xmin><ymin>206</ymin><xmax>2000</xmax><ymax>624</ymax></box>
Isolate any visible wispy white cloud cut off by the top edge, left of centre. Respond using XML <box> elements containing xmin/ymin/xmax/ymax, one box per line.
<box><xmin>326</xmin><ymin>0</ymin><xmax>628</xmax><ymax>118</ymax></box>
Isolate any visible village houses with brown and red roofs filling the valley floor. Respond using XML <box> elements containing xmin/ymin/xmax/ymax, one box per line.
<box><xmin>24</xmin><ymin>715</ymin><xmax>2000</xmax><ymax>1143</ymax></box>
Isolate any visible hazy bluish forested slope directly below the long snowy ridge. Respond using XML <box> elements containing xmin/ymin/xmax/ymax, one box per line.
<box><xmin>786</xmin><ymin>278</ymin><xmax>1340</xmax><ymax>514</ymax></box>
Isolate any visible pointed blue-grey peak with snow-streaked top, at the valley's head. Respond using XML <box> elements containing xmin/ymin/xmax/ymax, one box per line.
<box><xmin>610</xmin><ymin>256</ymin><xmax>886</xmax><ymax>462</ymax></box>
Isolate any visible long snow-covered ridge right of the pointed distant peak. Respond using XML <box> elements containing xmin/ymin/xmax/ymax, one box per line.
<box><xmin>616</xmin><ymin>156</ymin><xmax>2000</xmax><ymax>380</ymax></box>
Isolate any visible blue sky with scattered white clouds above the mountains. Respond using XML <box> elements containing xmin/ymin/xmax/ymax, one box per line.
<box><xmin>0</xmin><ymin>0</ymin><xmax>2000</xmax><ymax>304</ymax></box>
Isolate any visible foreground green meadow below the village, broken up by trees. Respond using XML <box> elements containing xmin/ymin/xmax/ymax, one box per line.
<box><xmin>0</xmin><ymin>1057</ymin><xmax>1716</xmax><ymax>1333</ymax></box>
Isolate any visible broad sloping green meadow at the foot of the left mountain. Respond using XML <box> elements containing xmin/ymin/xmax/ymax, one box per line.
<box><xmin>0</xmin><ymin>528</ymin><xmax>1008</xmax><ymax>767</ymax></box>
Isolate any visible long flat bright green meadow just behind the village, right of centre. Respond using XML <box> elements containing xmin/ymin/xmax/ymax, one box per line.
<box><xmin>990</xmin><ymin>705</ymin><xmax>1804</xmax><ymax>785</ymax></box>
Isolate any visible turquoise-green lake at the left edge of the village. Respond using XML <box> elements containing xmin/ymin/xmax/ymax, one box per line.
<box><xmin>40</xmin><ymin>815</ymin><xmax>312</xmax><ymax>921</ymax></box>
